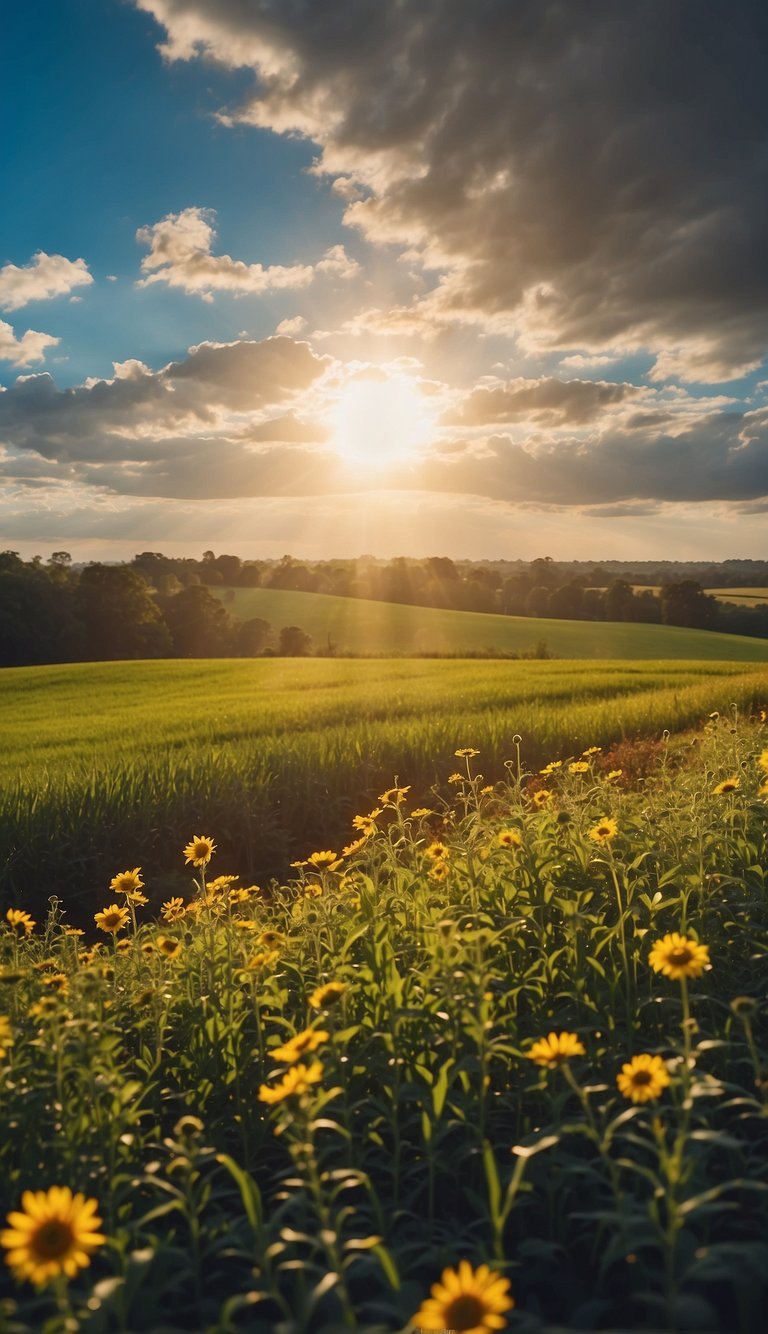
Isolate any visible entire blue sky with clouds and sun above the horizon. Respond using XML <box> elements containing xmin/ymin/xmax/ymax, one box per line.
<box><xmin>0</xmin><ymin>0</ymin><xmax>768</xmax><ymax>560</ymax></box>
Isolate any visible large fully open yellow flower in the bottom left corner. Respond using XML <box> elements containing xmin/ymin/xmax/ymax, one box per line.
<box><xmin>0</xmin><ymin>1186</ymin><xmax>107</xmax><ymax>1287</ymax></box>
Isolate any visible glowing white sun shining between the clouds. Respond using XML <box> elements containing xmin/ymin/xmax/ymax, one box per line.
<box><xmin>329</xmin><ymin>372</ymin><xmax>436</xmax><ymax>470</ymax></box>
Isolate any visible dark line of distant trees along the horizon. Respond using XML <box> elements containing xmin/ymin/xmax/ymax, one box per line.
<box><xmin>0</xmin><ymin>551</ymin><xmax>768</xmax><ymax>667</ymax></box>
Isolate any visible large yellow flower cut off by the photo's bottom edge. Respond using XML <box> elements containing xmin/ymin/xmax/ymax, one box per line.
<box><xmin>411</xmin><ymin>1259</ymin><xmax>515</xmax><ymax>1334</ymax></box>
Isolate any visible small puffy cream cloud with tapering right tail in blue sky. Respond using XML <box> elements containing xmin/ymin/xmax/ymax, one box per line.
<box><xmin>136</xmin><ymin>208</ymin><xmax>360</xmax><ymax>300</ymax></box>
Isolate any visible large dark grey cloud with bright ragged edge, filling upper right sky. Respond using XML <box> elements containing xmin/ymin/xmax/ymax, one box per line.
<box><xmin>135</xmin><ymin>0</ymin><xmax>768</xmax><ymax>382</ymax></box>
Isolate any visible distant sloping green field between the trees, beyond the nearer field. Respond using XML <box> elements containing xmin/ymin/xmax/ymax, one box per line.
<box><xmin>212</xmin><ymin>588</ymin><xmax>768</xmax><ymax>662</ymax></box>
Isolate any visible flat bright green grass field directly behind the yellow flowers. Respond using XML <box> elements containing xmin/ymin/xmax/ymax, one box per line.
<box><xmin>0</xmin><ymin>659</ymin><xmax>768</xmax><ymax>911</ymax></box>
